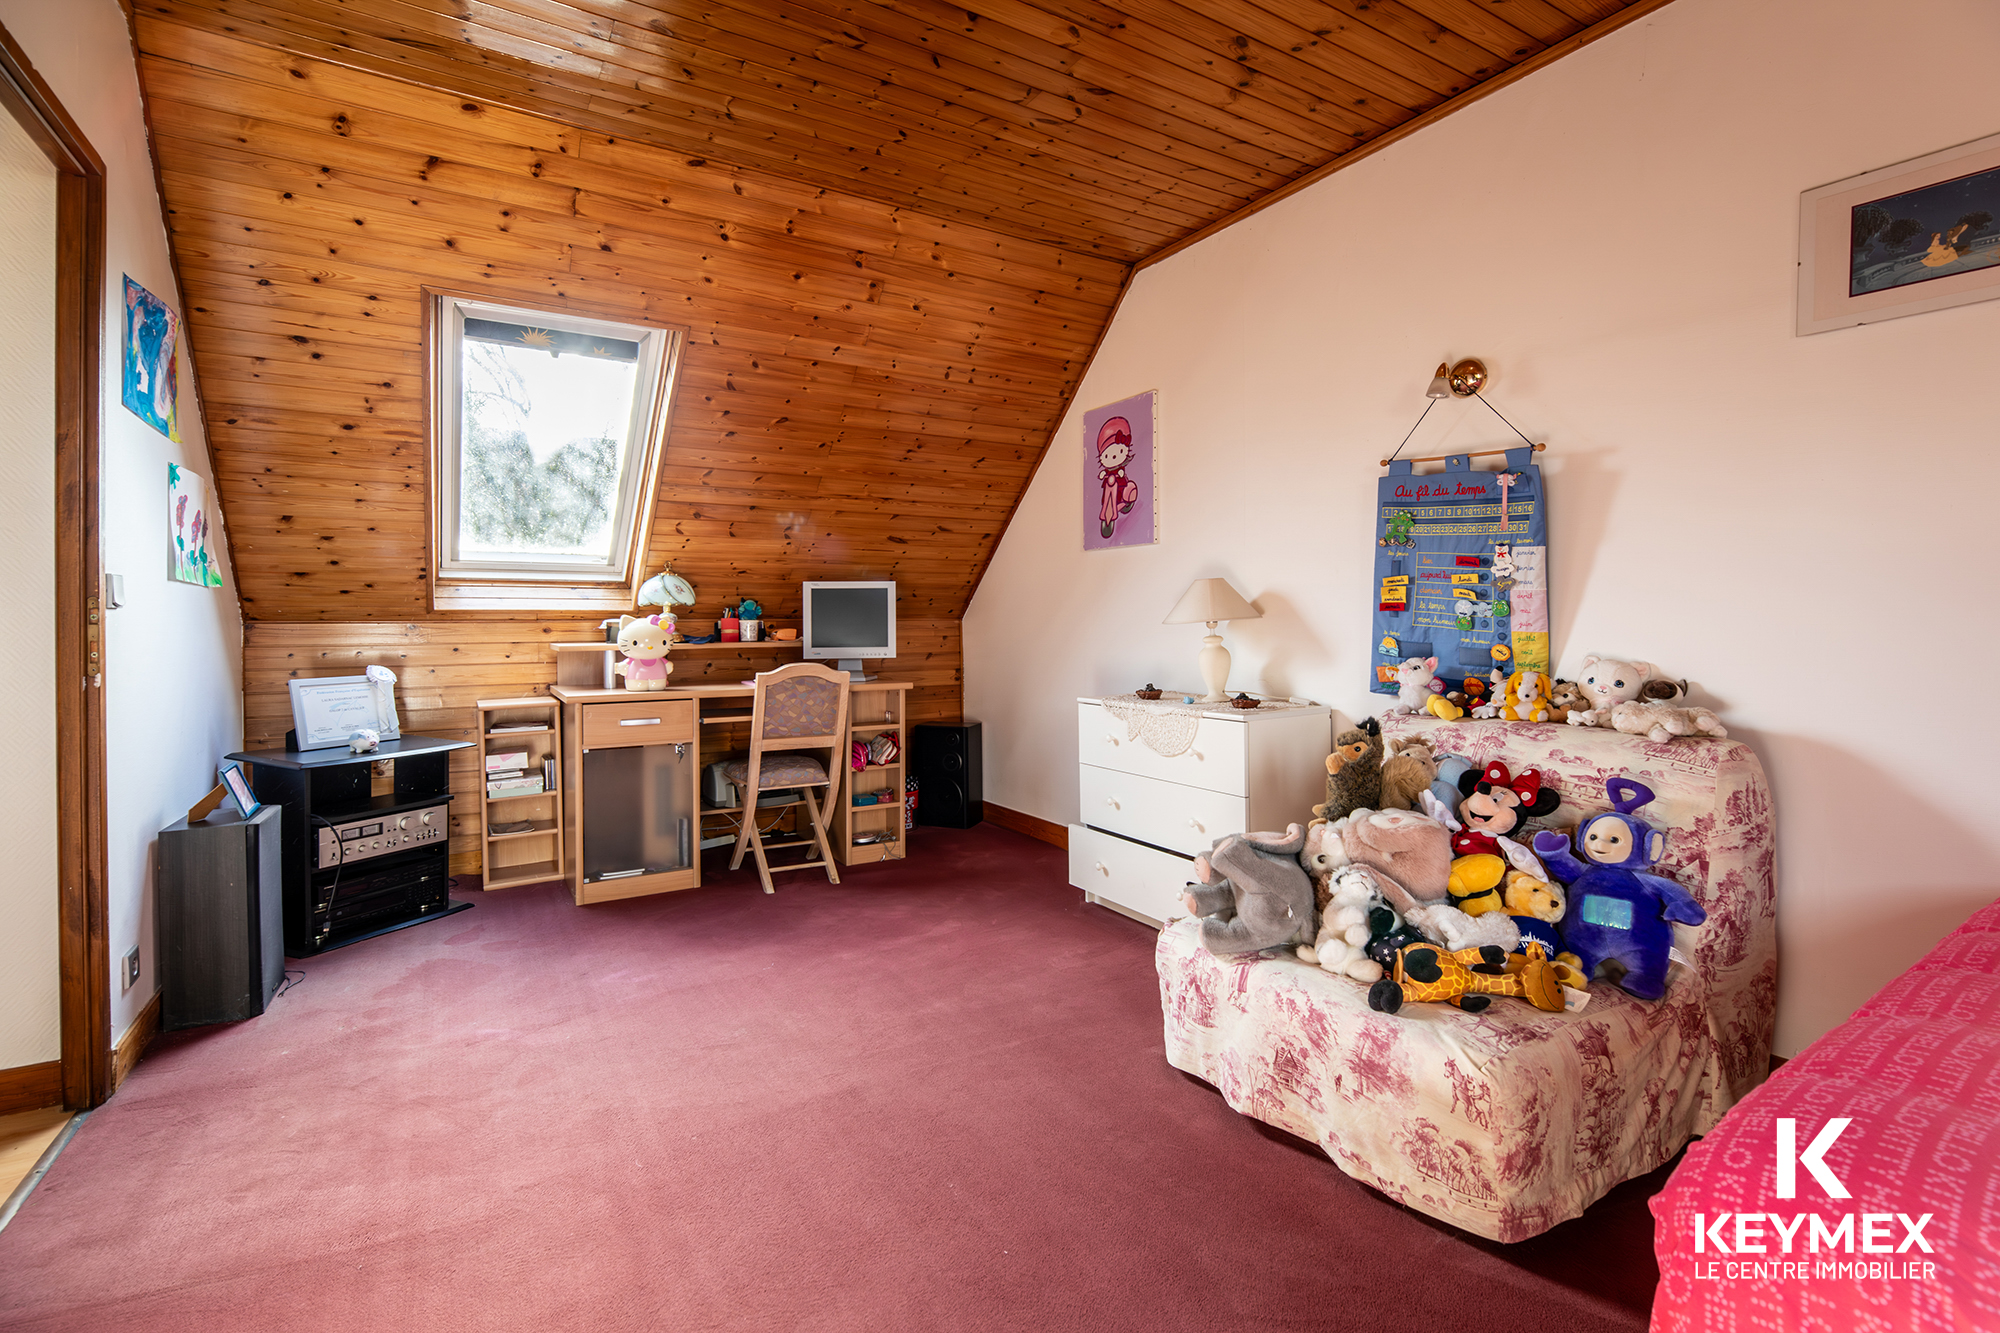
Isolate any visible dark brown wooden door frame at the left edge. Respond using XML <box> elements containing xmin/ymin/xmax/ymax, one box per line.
<box><xmin>0</xmin><ymin>24</ymin><xmax>112</xmax><ymax>1109</ymax></box>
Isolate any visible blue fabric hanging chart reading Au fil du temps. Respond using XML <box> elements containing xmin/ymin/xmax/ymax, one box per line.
<box><xmin>1368</xmin><ymin>446</ymin><xmax>1548</xmax><ymax>695</ymax></box>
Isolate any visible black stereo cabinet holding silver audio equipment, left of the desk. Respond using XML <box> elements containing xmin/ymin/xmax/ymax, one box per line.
<box><xmin>230</xmin><ymin>735</ymin><xmax>472</xmax><ymax>959</ymax></box>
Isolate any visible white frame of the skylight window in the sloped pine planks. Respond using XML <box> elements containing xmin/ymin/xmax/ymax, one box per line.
<box><xmin>426</xmin><ymin>290</ymin><xmax>686</xmax><ymax>610</ymax></box>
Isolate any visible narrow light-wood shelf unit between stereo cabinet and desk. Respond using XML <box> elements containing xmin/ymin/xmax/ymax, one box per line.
<box><xmin>476</xmin><ymin>695</ymin><xmax>564</xmax><ymax>889</ymax></box>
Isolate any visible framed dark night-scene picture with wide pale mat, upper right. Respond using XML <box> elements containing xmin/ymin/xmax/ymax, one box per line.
<box><xmin>1798</xmin><ymin>134</ymin><xmax>2000</xmax><ymax>336</ymax></box>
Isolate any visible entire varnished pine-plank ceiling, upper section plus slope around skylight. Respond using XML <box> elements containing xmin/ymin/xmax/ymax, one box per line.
<box><xmin>134</xmin><ymin>0</ymin><xmax>1664</xmax><ymax>620</ymax></box>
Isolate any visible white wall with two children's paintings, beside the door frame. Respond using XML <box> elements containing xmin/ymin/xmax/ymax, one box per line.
<box><xmin>0</xmin><ymin>0</ymin><xmax>242</xmax><ymax>1037</ymax></box>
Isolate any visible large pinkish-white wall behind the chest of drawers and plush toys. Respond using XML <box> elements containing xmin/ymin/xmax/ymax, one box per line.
<box><xmin>964</xmin><ymin>0</ymin><xmax>2000</xmax><ymax>1053</ymax></box>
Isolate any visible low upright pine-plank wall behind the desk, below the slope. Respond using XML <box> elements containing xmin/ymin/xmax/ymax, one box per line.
<box><xmin>244</xmin><ymin>618</ymin><xmax>964</xmax><ymax>875</ymax></box>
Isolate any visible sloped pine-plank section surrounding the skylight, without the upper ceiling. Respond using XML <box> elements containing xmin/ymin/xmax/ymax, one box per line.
<box><xmin>136</xmin><ymin>12</ymin><xmax>1126</xmax><ymax>622</ymax></box>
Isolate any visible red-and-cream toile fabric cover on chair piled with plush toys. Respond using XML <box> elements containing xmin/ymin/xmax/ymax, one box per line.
<box><xmin>1156</xmin><ymin>717</ymin><xmax>1778</xmax><ymax>1241</ymax></box>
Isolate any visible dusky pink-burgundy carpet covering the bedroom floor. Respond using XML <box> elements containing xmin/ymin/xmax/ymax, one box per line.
<box><xmin>0</xmin><ymin>827</ymin><xmax>1658</xmax><ymax>1333</ymax></box>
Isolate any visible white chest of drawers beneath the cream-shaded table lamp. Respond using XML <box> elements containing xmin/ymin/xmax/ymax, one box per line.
<box><xmin>1070</xmin><ymin>699</ymin><xmax>1332</xmax><ymax>925</ymax></box>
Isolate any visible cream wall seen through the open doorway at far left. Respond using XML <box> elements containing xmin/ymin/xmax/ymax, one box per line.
<box><xmin>0</xmin><ymin>110</ymin><xmax>62</xmax><ymax>1069</ymax></box>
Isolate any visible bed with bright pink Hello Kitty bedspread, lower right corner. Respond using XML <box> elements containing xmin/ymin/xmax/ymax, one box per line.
<box><xmin>1652</xmin><ymin>903</ymin><xmax>2000</xmax><ymax>1333</ymax></box>
